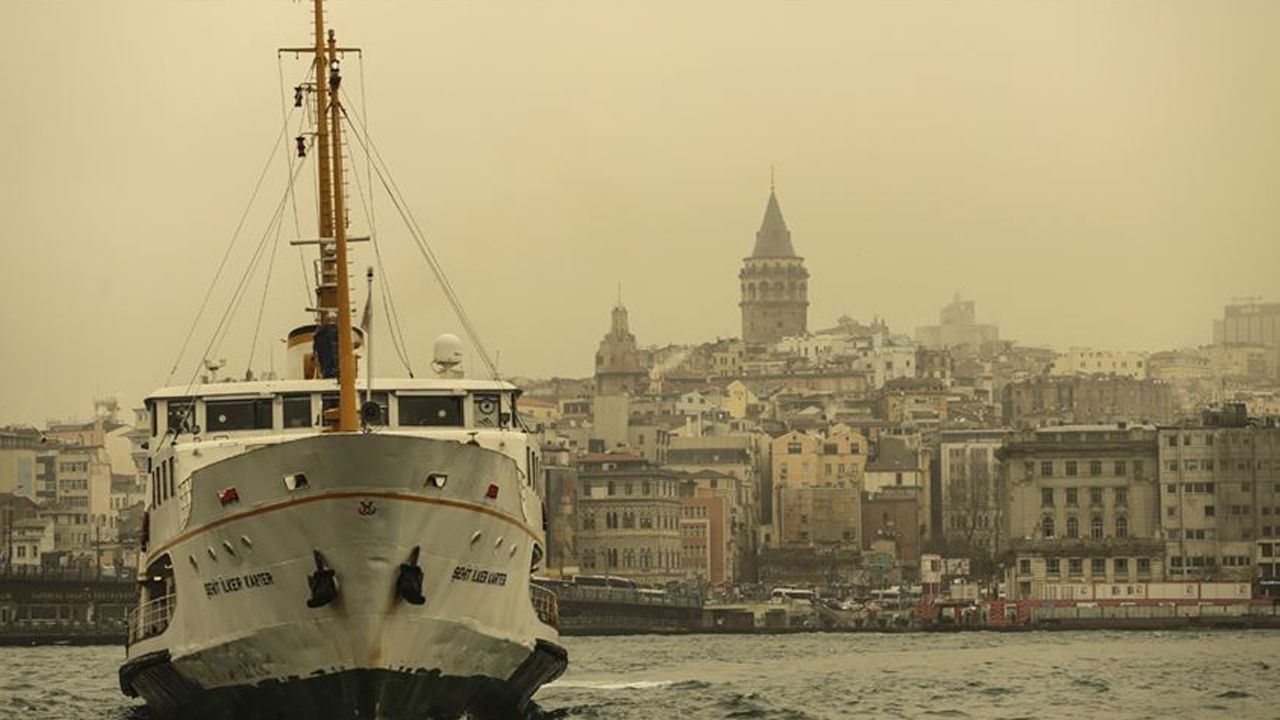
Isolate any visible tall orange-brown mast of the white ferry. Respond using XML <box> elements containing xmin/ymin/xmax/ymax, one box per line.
<box><xmin>305</xmin><ymin>0</ymin><xmax>358</xmax><ymax>432</ymax></box>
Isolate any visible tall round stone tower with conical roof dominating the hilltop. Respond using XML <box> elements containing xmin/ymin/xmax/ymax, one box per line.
<box><xmin>737</xmin><ymin>187</ymin><xmax>809</xmax><ymax>345</ymax></box>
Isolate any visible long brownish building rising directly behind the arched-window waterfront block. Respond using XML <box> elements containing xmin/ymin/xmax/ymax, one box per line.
<box><xmin>1001</xmin><ymin>375</ymin><xmax>1176</xmax><ymax>428</ymax></box>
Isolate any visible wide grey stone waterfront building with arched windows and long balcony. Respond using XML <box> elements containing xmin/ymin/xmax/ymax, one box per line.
<box><xmin>997</xmin><ymin>425</ymin><xmax>1165</xmax><ymax>600</ymax></box>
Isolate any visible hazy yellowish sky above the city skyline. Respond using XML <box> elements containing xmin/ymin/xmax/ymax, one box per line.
<box><xmin>0</xmin><ymin>0</ymin><xmax>1280</xmax><ymax>423</ymax></box>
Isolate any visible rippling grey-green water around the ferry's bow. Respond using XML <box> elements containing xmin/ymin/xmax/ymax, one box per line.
<box><xmin>0</xmin><ymin>630</ymin><xmax>1280</xmax><ymax>720</ymax></box>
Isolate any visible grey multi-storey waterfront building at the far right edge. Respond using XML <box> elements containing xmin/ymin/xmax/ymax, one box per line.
<box><xmin>1158</xmin><ymin>409</ymin><xmax>1280</xmax><ymax>582</ymax></box>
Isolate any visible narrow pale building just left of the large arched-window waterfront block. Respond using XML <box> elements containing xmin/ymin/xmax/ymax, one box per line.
<box><xmin>938</xmin><ymin>429</ymin><xmax>1009</xmax><ymax>560</ymax></box>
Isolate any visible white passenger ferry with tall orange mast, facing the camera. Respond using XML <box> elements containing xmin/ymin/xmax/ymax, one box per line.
<box><xmin>119</xmin><ymin>0</ymin><xmax>567</xmax><ymax>720</ymax></box>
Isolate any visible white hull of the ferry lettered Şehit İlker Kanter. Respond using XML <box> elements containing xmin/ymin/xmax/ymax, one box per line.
<box><xmin>120</xmin><ymin>433</ymin><xmax>566</xmax><ymax>719</ymax></box>
